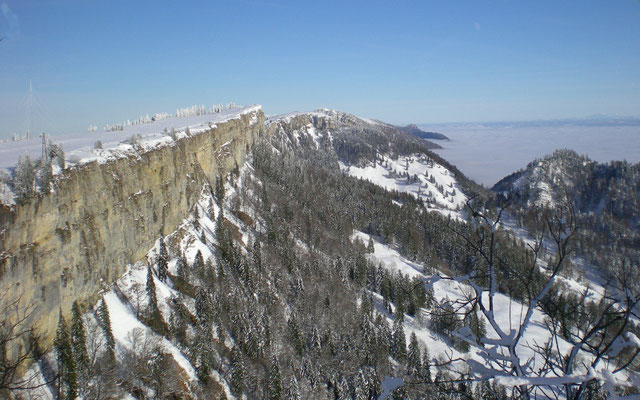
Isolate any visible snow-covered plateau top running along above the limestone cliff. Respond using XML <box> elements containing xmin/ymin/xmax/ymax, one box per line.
<box><xmin>0</xmin><ymin>105</ymin><xmax>262</xmax><ymax>171</ymax></box>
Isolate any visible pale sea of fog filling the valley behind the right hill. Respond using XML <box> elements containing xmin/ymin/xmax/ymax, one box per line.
<box><xmin>420</xmin><ymin>123</ymin><xmax>640</xmax><ymax>187</ymax></box>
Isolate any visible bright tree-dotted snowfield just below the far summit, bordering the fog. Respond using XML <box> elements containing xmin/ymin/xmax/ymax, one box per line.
<box><xmin>340</xmin><ymin>154</ymin><xmax>468</xmax><ymax>218</ymax></box>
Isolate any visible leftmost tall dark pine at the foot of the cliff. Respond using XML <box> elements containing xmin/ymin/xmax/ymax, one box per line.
<box><xmin>54</xmin><ymin>310</ymin><xmax>78</xmax><ymax>400</ymax></box>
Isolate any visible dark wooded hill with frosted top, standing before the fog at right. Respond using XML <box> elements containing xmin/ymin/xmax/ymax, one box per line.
<box><xmin>492</xmin><ymin>150</ymin><xmax>640</xmax><ymax>273</ymax></box>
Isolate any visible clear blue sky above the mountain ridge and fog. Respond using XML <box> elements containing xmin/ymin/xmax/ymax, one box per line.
<box><xmin>0</xmin><ymin>0</ymin><xmax>640</xmax><ymax>136</ymax></box>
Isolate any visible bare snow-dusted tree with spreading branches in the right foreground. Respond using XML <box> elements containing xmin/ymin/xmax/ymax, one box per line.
<box><xmin>429</xmin><ymin>201</ymin><xmax>640</xmax><ymax>400</ymax></box>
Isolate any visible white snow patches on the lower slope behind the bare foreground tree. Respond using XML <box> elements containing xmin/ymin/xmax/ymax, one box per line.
<box><xmin>352</xmin><ymin>232</ymin><xmax>628</xmax><ymax>398</ymax></box>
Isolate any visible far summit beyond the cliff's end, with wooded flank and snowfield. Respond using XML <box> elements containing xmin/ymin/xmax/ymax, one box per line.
<box><xmin>267</xmin><ymin>109</ymin><xmax>468</xmax><ymax>217</ymax></box>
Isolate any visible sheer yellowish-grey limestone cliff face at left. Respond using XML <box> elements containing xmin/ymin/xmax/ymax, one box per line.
<box><xmin>0</xmin><ymin>110</ymin><xmax>266</xmax><ymax>348</ymax></box>
